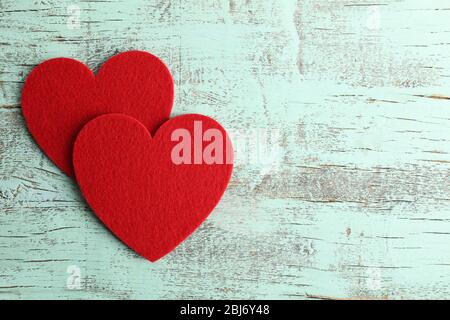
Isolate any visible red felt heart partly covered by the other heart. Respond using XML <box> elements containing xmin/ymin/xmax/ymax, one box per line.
<box><xmin>22</xmin><ymin>51</ymin><xmax>173</xmax><ymax>176</ymax></box>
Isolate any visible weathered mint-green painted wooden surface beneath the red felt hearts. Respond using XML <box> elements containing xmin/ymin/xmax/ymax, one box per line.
<box><xmin>0</xmin><ymin>0</ymin><xmax>450</xmax><ymax>299</ymax></box>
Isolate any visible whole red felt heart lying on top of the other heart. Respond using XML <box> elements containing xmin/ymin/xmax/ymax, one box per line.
<box><xmin>73</xmin><ymin>114</ymin><xmax>233</xmax><ymax>261</ymax></box>
